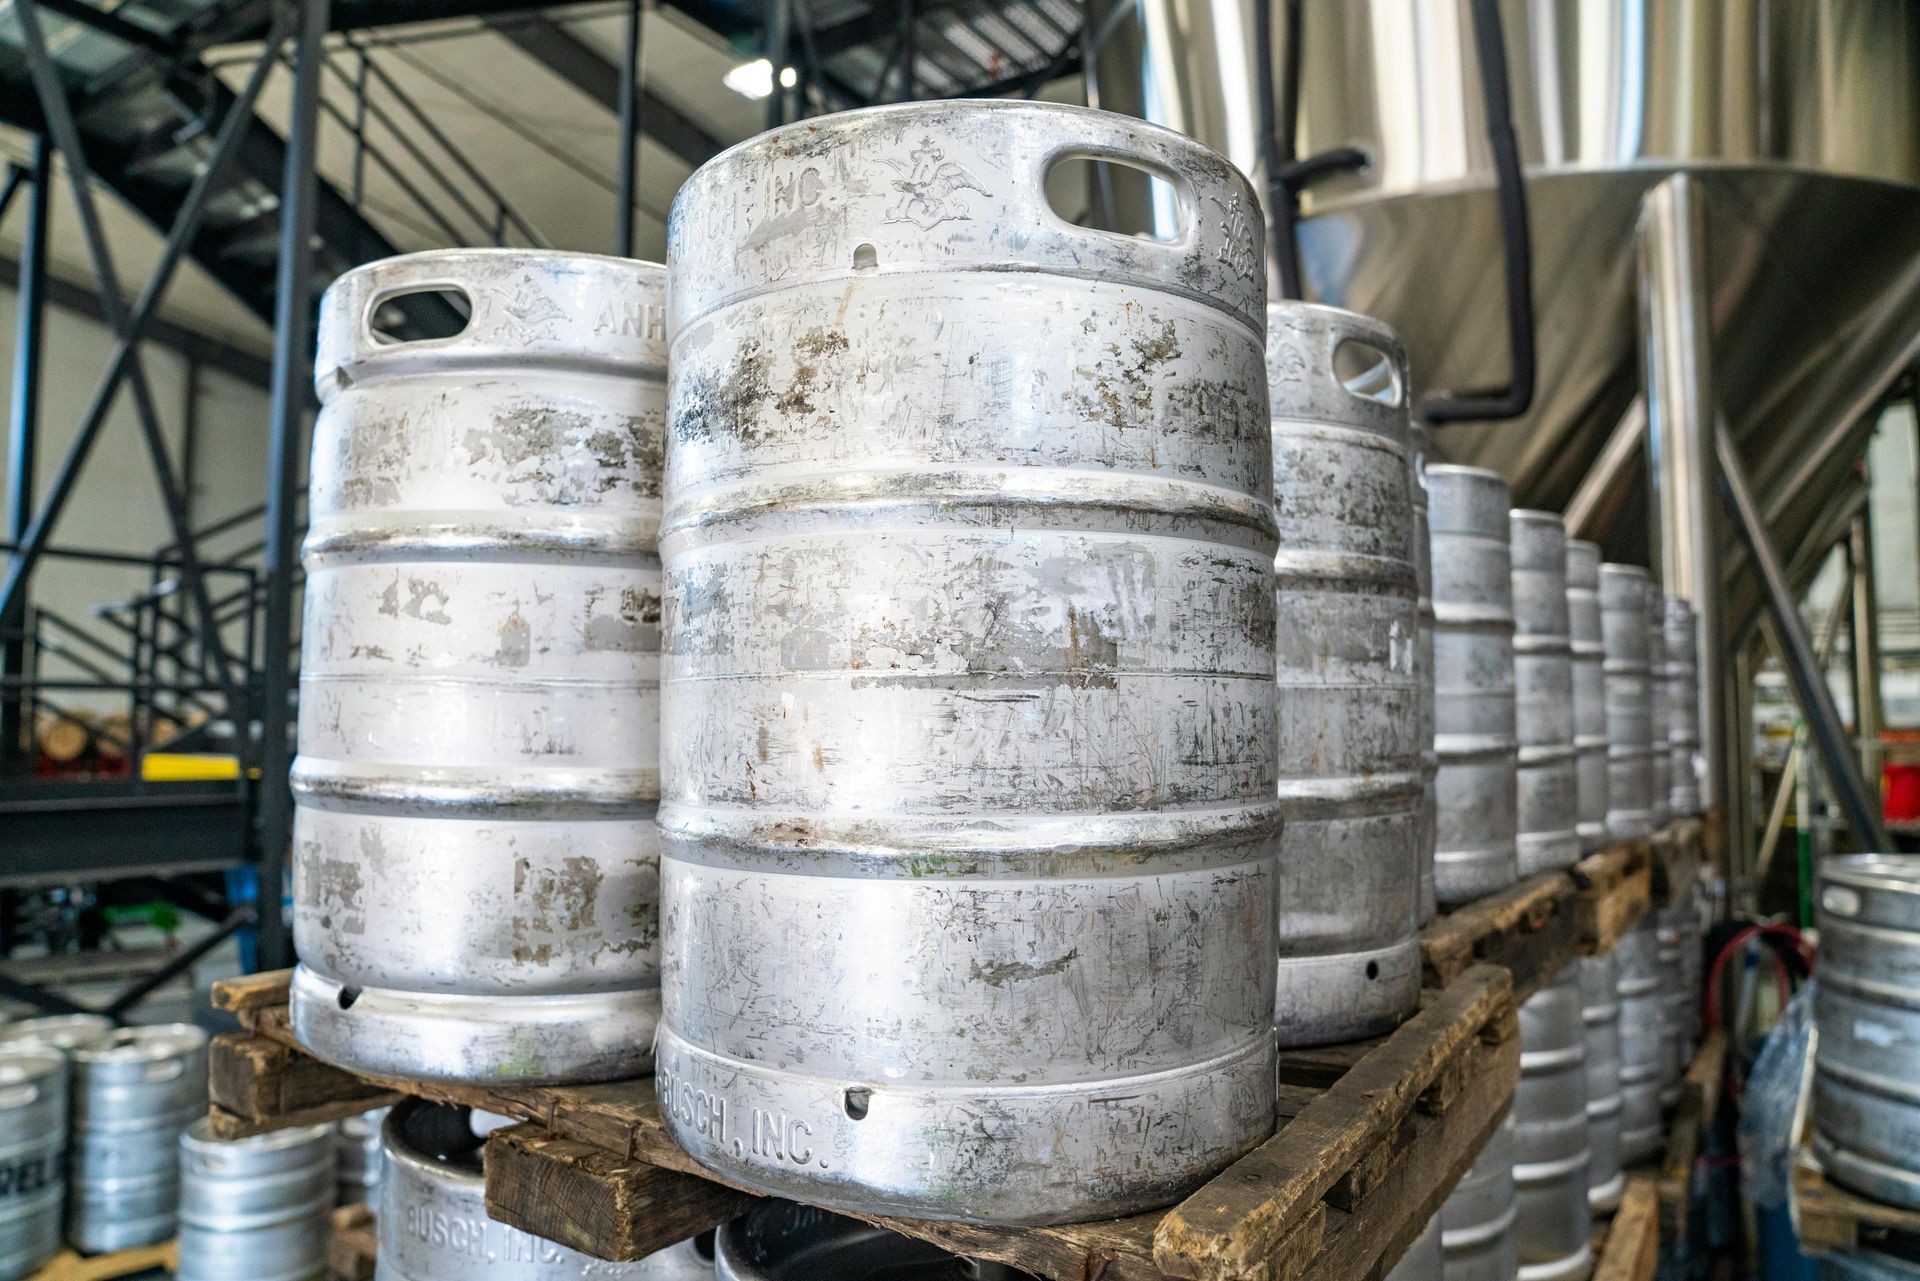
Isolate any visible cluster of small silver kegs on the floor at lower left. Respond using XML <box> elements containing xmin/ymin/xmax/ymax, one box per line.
<box><xmin>0</xmin><ymin>1014</ymin><xmax>382</xmax><ymax>1281</ymax></box>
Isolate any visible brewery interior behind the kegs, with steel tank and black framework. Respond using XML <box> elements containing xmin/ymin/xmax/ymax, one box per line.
<box><xmin>0</xmin><ymin>0</ymin><xmax>1920</xmax><ymax>1277</ymax></box>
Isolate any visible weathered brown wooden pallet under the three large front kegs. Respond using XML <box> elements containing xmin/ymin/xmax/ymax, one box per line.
<box><xmin>209</xmin><ymin>966</ymin><xmax>1521</xmax><ymax>1281</ymax></box>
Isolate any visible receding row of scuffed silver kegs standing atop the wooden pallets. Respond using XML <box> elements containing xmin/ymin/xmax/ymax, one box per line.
<box><xmin>280</xmin><ymin>102</ymin><xmax>1699</xmax><ymax>1223</ymax></box>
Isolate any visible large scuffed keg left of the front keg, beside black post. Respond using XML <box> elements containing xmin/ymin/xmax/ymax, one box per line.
<box><xmin>292</xmin><ymin>250</ymin><xmax>666</xmax><ymax>1083</ymax></box>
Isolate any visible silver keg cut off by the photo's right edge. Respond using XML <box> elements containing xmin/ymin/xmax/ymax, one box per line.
<box><xmin>1812</xmin><ymin>855</ymin><xmax>1920</xmax><ymax>1208</ymax></box>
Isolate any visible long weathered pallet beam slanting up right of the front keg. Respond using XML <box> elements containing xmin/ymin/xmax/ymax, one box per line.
<box><xmin>1154</xmin><ymin>967</ymin><xmax>1520</xmax><ymax>1277</ymax></box>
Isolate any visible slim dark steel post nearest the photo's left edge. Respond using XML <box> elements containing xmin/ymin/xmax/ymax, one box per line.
<box><xmin>0</xmin><ymin>134</ymin><xmax>54</xmax><ymax>774</ymax></box>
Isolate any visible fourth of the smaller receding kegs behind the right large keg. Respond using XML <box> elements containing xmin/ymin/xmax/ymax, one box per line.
<box><xmin>1599</xmin><ymin>563</ymin><xmax>1653</xmax><ymax>841</ymax></box>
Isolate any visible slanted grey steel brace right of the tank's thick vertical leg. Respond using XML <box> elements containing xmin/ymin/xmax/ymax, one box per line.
<box><xmin>1701</xmin><ymin>423</ymin><xmax>1893</xmax><ymax>851</ymax></box>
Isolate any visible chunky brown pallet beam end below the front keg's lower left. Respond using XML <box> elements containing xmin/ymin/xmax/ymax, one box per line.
<box><xmin>486</xmin><ymin>1125</ymin><xmax>760</xmax><ymax>1262</ymax></box>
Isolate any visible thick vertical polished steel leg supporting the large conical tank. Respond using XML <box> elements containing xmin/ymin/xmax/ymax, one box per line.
<box><xmin>1638</xmin><ymin>173</ymin><xmax>1730</xmax><ymax>825</ymax></box>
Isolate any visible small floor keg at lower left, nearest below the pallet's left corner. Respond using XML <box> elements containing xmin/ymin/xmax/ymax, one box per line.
<box><xmin>175</xmin><ymin>1118</ymin><xmax>334</xmax><ymax>1281</ymax></box>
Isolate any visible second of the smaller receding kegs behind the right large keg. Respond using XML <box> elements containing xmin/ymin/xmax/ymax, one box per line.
<box><xmin>1509</xmin><ymin>511</ymin><xmax>1580</xmax><ymax>876</ymax></box>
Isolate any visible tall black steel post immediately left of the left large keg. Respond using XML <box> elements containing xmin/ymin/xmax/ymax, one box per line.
<box><xmin>259</xmin><ymin>0</ymin><xmax>328</xmax><ymax>970</ymax></box>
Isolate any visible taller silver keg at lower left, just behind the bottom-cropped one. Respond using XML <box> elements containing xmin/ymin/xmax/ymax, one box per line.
<box><xmin>67</xmin><ymin>1024</ymin><xmax>207</xmax><ymax>1254</ymax></box>
